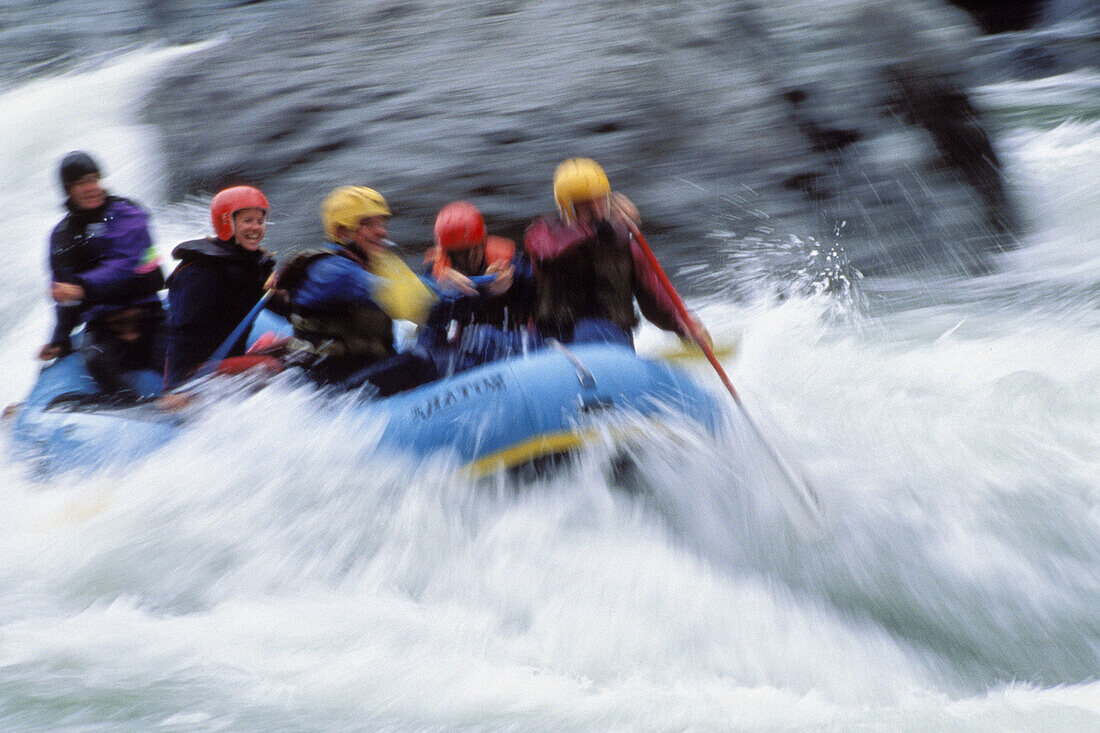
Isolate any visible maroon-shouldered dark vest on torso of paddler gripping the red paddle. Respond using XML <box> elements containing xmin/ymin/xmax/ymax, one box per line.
<box><xmin>526</xmin><ymin>219</ymin><xmax>638</xmax><ymax>335</ymax></box>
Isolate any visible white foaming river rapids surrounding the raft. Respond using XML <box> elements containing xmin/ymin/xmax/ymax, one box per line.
<box><xmin>0</xmin><ymin>48</ymin><xmax>1100</xmax><ymax>731</ymax></box>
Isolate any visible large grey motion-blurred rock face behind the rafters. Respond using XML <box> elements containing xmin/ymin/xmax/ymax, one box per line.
<box><xmin>0</xmin><ymin>0</ymin><xmax>1016</xmax><ymax>273</ymax></box>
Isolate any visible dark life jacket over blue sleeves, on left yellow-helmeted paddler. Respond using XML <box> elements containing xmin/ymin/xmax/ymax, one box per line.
<box><xmin>275</xmin><ymin>248</ymin><xmax>396</xmax><ymax>368</ymax></box>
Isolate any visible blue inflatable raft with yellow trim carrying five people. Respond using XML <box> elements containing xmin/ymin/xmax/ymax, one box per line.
<box><xmin>11</xmin><ymin>313</ymin><xmax>719</xmax><ymax>477</ymax></box>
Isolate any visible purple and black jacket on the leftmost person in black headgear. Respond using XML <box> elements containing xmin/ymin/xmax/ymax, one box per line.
<box><xmin>50</xmin><ymin>196</ymin><xmax>164</xmax><ymax>347</ymax></box>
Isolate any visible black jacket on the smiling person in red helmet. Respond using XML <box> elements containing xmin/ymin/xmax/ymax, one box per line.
<box><xmin>165</xmin><ymin>239</ymin><xmax>275</xmax><ymax>389</ymax></box>
